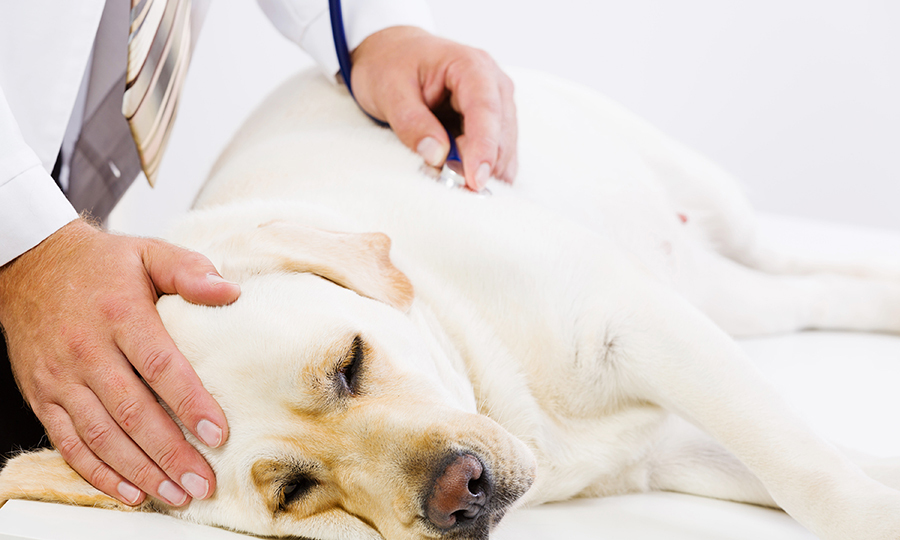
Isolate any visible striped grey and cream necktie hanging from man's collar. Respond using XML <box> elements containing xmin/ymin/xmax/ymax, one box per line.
<box><xmin>65</xmin><ymin>0</ymin><xmax>209</xmax><ymax>221</ymax></box>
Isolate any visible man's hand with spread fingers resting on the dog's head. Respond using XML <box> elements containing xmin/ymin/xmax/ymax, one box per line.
<box><xmin>0</xmin><ymin>220</ymin><xmax>240</xmax><ymax>506</ymax></box>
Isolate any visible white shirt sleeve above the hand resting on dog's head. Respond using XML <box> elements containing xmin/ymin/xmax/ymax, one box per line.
<box><xmin>0</xmin><ymin>88</ymin><xmax>78</xmax><ymax>265</ymax></box>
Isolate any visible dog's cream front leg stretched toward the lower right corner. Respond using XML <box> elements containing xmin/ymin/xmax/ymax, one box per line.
<box><xmin>611</xmin><ymin>289</ymin><xmax>900</xmax><ymax>540</ymax></box>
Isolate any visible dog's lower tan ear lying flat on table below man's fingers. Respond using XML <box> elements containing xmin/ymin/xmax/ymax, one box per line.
<box><xmin>0</xmin><ymin>449</ymin><xmax>137</xmax><ymax>510</ymax></box>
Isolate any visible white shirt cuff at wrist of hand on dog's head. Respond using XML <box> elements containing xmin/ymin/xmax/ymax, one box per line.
<box><xmin>0</xmin><ymin>164</ymin><xmax>78</xmax><ymax>265</ymax></box>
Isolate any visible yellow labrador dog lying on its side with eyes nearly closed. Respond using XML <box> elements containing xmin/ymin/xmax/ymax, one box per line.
<box><xmin>0</xmin><ymin>68</ymin><xmax>900</xmax><ymax>540</ymax></box>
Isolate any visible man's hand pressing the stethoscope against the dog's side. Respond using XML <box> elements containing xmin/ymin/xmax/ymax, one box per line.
<box><xmin>350</xmin><ymin>26</ymin><xmax>518</xmax><ymax>191</ymax></box>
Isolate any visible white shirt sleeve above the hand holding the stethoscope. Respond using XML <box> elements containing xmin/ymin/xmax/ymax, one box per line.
<box><xmin>257</xmin><ymin>0</ymin><xmax>434</xmax><ymax>77</ymax></box>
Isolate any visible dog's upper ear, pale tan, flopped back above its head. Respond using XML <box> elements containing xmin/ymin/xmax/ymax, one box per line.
<box><xmin>208</xmin><ymin>221</ymin><xmax>414</xmax><ymax>312</ymax></box>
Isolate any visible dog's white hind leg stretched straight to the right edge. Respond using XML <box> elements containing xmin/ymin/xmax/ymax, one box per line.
<box><xmin>678</xmin><ymin>242</ymin><xmax>900</xmax><ymax>336</ymax></box>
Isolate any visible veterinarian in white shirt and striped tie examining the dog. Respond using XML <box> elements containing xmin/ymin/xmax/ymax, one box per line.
<box><xmin>0</xmin><ymin>0</ymin><xmax>516</xmax><ymax>506</ymax></box>
